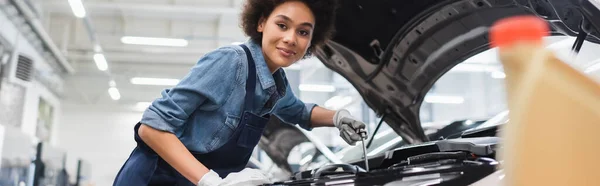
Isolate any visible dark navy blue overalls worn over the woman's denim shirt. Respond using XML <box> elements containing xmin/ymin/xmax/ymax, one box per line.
<box><xmin>113</xmin><ymin>45</ymin><xmax>269</xmax><ymax>186</ymax></box>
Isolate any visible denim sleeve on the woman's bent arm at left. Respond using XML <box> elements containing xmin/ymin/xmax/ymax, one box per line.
<box><xmin>140</xmin><ymin>48</ymin><xmax>243</xmax><ymax>133</ymax></box>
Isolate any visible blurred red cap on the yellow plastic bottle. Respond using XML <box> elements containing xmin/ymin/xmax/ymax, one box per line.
<box><xmin>490</xmin><ymin>15</ymin><xmax>550</xmax><ymax>47</ymax></box>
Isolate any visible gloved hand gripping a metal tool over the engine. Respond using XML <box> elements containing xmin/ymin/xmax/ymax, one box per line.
<box><xmin>333</xmin><ymin>109</ymin><xmax>366</xmax><ymax>145</ymax></box>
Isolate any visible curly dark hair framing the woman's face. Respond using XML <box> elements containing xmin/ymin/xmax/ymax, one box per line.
<box><xmin>240</xmin><ymin>0</ymin><xmax>338</xmax><ymax>57</ymax></box>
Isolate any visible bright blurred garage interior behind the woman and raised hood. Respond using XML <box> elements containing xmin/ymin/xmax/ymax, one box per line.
<box><xmin>0</xmin><ymin>0</ymin><xmax>600</xmax><ymax>186</ymax></box>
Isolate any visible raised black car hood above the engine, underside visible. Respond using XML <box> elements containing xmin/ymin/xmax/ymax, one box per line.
<box><xmin>315</xmin><ymin>0</ymin><xmax>598</xmax><ymax>143</ymax></box>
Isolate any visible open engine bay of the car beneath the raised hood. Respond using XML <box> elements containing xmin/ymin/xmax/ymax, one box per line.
<box><xmin>271</xmin><ymin>126</ymin><xmax>500</xmax><ymax>185</ymax></box>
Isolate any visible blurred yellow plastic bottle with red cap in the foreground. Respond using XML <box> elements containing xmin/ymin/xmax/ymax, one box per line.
<box><xmin>490</xmin><ymin>16</ymin><xmax>600</xmax><ymax>186</ymax></box>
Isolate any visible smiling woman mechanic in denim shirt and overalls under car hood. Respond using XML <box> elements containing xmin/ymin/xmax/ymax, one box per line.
<box><xmin>114</xmin><ymin>0</ymin><xmax>365</xmax><ymax>186</ymax></box>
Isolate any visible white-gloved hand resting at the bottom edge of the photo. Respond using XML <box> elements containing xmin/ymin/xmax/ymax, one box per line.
<box><xmin>197</xmin><ymin>168</ymin><xmax>272</xmax><ymax>186</ymax></box>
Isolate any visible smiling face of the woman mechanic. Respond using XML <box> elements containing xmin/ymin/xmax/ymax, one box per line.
<box><xmin>257</xmin><ymin>1</ymin><xmax>315</xmax><ymax>72</ymax></box>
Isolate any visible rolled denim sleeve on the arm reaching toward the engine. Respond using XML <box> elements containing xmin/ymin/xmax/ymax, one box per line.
<box><xmin>273</xmin><ymin>77</ymin><xmax>317</xmax><ymax>131</ymax></box>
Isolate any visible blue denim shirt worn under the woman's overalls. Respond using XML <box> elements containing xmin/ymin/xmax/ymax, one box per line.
<box><xmin>140</xmin><ymin>40</ymin><xmax>316</xmax><ymax>153</ymax></box>
